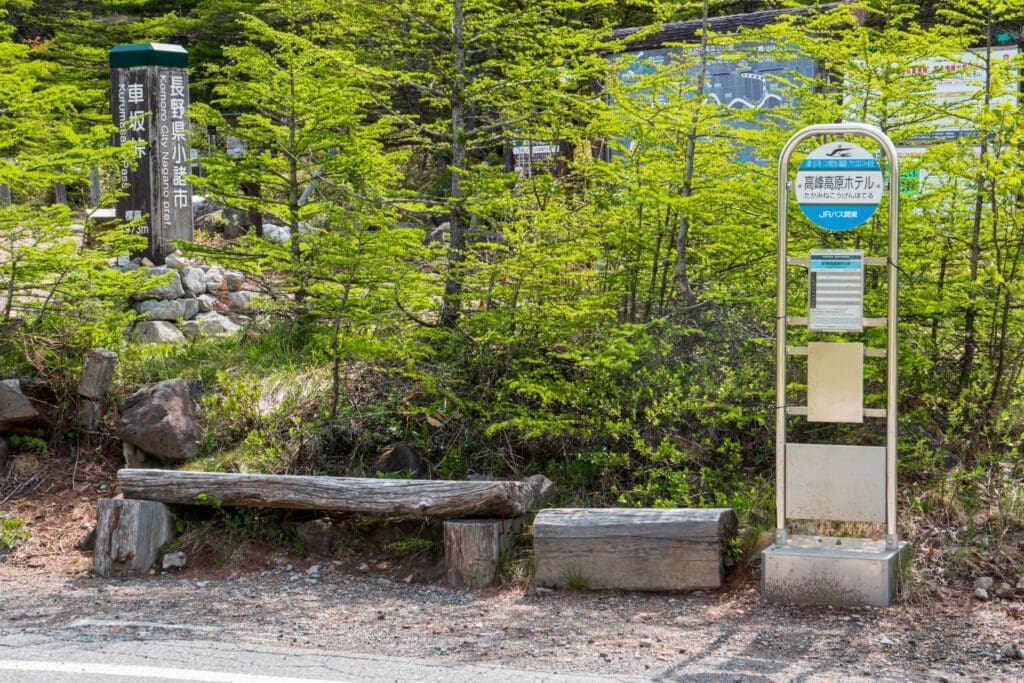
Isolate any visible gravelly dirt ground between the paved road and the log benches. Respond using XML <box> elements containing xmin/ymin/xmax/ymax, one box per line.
<box><xmin>0</xmin><ymin>466</ymin><xmax>1024</xmax><ymax>681</ymax></box>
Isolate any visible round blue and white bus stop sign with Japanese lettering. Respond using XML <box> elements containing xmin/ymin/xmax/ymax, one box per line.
<box><xmin>796</xmin><ymin>140</ymin><xmax>885</xmax><ymax>231</ymax></box>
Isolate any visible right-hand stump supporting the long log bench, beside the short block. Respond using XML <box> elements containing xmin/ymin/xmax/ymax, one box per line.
<box><xmin>444</xmin><ymin>518</ymin><xmax>522</xmax><ymax>588</ymax></box>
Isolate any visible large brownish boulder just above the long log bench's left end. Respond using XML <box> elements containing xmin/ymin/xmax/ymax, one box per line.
<box><xmin>114</xmin><ymin>376</ymin><xmax>204</xmax><ymax>462</ymax></box>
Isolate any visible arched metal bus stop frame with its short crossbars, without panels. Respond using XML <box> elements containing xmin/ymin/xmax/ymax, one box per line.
<box><xmin>775</xmin><ymin>123</ymin><xmax>900</xmax><ymax>550</ymax></box>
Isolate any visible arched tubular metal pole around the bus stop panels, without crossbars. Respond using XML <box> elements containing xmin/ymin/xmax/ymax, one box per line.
<box><xmin>775</xmin><ymin>123</ymin><xmax>899</xmax><ymax>549</ymax></box>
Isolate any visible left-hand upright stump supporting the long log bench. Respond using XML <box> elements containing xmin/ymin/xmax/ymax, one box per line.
<box><xmin>92</xmin><ymin>498</ymin><xmax>174</xmax><ymax>577</ymax></box>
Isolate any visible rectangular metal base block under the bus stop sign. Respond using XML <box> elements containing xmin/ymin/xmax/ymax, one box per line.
<box><xmin>761</xmin><ymin>536</ymin><xmax>910</xmax><ymax>607</ymax></box>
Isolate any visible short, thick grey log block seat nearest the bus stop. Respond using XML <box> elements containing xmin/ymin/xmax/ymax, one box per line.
<box><xmin>534</xmin><ymin>508</ymin><xmax>736</xmax><ymax>591</ymax></box>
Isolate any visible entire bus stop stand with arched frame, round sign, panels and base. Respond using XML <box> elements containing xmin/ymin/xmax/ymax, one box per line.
<box><xmin>762</xmin><ymin>123</ymin><xmax>908</xmax><ymax>606</ymax></box>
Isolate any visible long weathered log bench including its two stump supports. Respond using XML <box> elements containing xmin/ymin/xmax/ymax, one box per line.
<box><xmin>94</xmin><ymin>468</ymin><xmax>553</xmax><ymax>588</ymax></box>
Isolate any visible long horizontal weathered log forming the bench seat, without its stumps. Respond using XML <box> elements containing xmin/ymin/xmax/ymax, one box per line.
<box><xmin>118</xmin><ymin>468</ymin><xmax>551</xmax><ymax>517</ymax></box>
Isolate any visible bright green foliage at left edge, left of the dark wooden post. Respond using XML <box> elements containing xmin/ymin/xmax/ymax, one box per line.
<box><xmin>0</xmin><ymin>6</ymin><xmax>147</xmax><ymax>426</ymax></box>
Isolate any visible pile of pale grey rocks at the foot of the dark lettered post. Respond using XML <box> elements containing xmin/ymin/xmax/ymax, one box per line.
<box><xmin>128</xmin><ymin>254</ymin><xmax>259</xmax><ymax>344</ymax></box>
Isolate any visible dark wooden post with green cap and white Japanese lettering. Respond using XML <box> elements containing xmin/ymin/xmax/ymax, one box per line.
<box><xmin>110</xmin><ymin>43</ymin><xmax>193</xmax><ymax>263</ymax></box>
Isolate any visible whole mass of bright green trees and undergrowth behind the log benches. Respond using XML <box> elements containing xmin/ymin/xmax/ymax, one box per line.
<box><xmin>0</xmin><ymin>0</ymin><xmax>1024</xmax><ymax>581</ymax></box>
